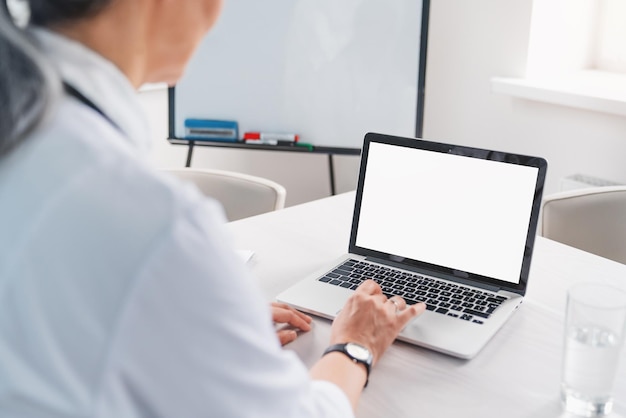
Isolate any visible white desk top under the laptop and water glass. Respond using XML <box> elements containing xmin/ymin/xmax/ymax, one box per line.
<box><xmin>229</xmin><ymin>193</ymin><xmax>626</xmax><ymax>418</ymax></box>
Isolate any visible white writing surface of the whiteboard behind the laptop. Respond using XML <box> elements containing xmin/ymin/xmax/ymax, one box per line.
<box><xmin>170</xmin><ymin>0</ymin><xmax>422</xmax><ymax>148</ymax></box>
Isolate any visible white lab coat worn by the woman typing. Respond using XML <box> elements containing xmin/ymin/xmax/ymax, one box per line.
<box><xmin>0</xmin><ymin>30</ymin><xmax>352</xmax><ymax>418</ymax></box>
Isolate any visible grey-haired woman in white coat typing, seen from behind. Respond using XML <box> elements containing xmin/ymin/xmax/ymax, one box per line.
<box><xmin>0</xmin><ymin>0</ymin><xmax>424</xmax><ymax>417</ymax></box>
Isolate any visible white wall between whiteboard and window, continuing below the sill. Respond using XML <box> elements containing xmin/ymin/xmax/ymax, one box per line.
<box><xmin>424</xmin><ymin>0</ymin><xmax>626</xmax><ymax>193</ymax></box>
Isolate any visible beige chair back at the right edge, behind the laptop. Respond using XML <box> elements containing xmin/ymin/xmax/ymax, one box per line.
<box><xmin>540</xmin><ymin>186</ymin><xmax>626</xmax><ymax>264</ymax></box>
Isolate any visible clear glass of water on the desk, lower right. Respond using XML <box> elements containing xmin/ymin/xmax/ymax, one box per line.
<box><xmin>561</xmin><ymin>279</ymin><xmax>626</xmax><ymax>417</ymax></box>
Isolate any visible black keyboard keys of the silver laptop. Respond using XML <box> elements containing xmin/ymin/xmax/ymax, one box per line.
<box><xmin>319</xmin><ymin>260</ymin><xmax>507</xmax><ymax>324</ymax></box>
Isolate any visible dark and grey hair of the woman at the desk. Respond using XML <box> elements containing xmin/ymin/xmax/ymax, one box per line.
<box><xmin>0</xmin><ymin>0</ymin><xmax>115</xmax><ymax>157</ymax></box>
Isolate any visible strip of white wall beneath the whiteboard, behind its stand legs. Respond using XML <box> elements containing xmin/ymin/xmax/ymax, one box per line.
<box><xmin>139</xmin><ymin>89</ymin><xmax>359</xmax><ymax>206</ymax></box>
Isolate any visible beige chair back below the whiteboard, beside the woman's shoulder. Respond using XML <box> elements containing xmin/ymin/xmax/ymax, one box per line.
<box><xmin>164</xmin><ymin>168</ymin><xmax>287</xmax><ymax>221</ymax></box>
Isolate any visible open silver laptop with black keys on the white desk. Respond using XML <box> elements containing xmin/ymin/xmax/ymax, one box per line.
<box><xmin>277</xmin><ymin>133</ymin><xmax>547</xmax><ymax>359</ymax></box>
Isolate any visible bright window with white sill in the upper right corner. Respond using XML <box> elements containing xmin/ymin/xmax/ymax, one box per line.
<box><xmin>491</xmin><ymin>0</ymin><xmax>626</xmax><ymax>116</ymax></box>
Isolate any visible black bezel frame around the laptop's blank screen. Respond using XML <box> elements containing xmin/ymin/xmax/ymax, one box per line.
<box><xmin>349</xmin><ymin>132</ymin><xmax>547</xmax><ymax>295</ymax></box>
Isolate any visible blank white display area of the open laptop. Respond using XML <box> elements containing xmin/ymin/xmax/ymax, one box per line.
<box><xmin>356</xmin><ymin>142</ymin><xmax>539</xmax><ymax>284</ymax></box>
